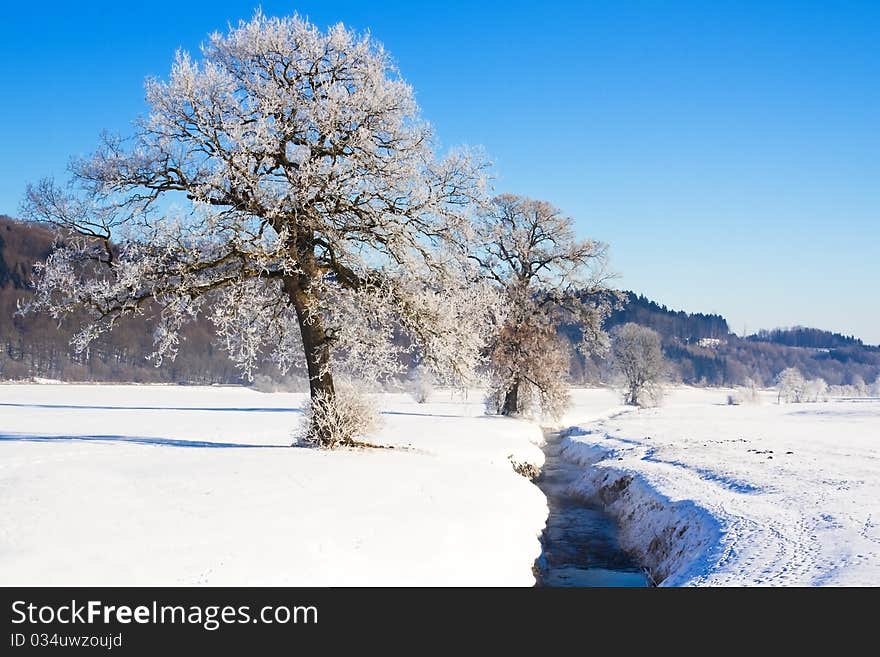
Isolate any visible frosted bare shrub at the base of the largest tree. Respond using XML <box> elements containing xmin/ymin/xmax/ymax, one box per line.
<box><xmin>296</xmin><ymin>384</ymin><xmax>381</xmax><ymax>449</ymax></box>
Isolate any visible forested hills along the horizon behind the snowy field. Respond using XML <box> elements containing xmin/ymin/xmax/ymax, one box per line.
<box><xmin>0</xmin><ymin>216</ymin><xmax>880</xmax><ymax>385</ymax></box>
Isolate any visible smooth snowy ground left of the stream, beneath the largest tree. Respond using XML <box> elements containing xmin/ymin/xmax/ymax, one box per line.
<box><xmin>0</xmin><ymin>385</ymin><xmax>547</xmax><ymax>586</ymax></box>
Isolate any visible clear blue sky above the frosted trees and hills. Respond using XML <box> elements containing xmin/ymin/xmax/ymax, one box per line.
<box><xmin>0</xmin><ymin>0</ymin><xmax>880</xmax><ymax>344</ymax></box>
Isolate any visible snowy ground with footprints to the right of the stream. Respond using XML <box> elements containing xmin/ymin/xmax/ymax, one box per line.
<box><xmin>563</xmin><ymin>388</ymin><xmax>880</xmax><ymax>586</ymax></box>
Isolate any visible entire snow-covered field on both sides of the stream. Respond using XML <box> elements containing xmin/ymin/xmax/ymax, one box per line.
<box><xmin>0</xmin><ymin>385</ymin><xmax>880</xmax><ymax>586</ymax></box>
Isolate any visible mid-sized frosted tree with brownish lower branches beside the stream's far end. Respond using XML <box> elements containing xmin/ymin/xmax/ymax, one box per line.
<box><xmin>470</xmin><ymin>194</ymin><xmax>616</xmax><ymax>417</ymax></box>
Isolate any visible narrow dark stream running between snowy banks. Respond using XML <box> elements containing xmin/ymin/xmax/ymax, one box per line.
<box><xmin>535</xmin><ymin>432</ymin><xmax>648</xmax><ymax>587</ymax></box>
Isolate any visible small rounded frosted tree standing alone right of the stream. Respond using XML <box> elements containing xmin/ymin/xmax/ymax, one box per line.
<box><xmin>611</xmin><ymin>322</ymin><xmax>669</xmax><ymax>406</ymax></box>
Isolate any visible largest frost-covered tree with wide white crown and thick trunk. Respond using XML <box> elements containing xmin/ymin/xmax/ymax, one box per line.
<box><xmin>24</xmin><ymin>13</ymin><xmax>489</xmax><ymax>444</ymax></box>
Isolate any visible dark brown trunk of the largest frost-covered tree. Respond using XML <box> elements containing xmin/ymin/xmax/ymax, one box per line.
<box><xmin>283</xmin><ymin>228</ymin><xmax>336</xmax><ymax>445</ymax></box>
